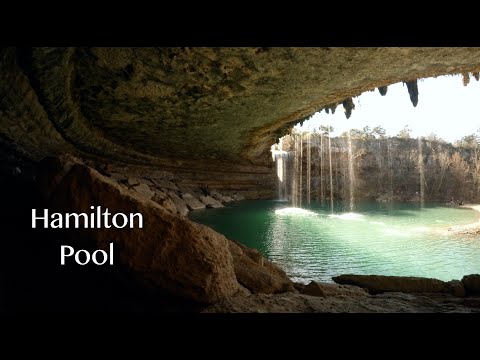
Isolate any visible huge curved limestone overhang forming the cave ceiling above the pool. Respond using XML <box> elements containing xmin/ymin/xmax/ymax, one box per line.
<box><xmin>0</xmin><ymin>48</ymin><xmax>480</xmax><ymax>197</ymax></box>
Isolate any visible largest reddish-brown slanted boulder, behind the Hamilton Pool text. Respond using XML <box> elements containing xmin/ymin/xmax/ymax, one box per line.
<box><xmin>38</xmin><ymin>160</ymin><xmax>248</xmax><ymax>303</ymax></box>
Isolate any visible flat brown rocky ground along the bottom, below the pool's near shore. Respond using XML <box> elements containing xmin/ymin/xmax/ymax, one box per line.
<box><xmin>203</xmin><ymin>292</ymin><xmax>480</xmax><ymax>313</ymax></box>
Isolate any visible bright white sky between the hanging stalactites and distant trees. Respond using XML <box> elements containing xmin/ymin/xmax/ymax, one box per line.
<box><xmin>296</xmin><ymin>75</ymin><xmax>480</xmax><ymax>142</ymax></box>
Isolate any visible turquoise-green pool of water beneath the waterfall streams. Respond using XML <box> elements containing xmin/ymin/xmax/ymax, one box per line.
<box><xmin>190</xmin><ymin>200</ymin><xmax>480</xmax><ymax>282</ymax></box>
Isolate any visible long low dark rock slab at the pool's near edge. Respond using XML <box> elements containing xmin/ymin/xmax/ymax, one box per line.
<box><xmin>332</xmin><ymin>274</ymin><xmax>465</xmax><ymax>297</ymax></box>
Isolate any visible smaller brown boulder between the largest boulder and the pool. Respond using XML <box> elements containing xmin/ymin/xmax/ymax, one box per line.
<box><xmin>228</xmin><ymin>241</ymin><xmax>296</xmax><ymax>294</ymax></box>
